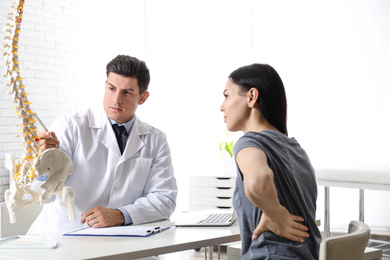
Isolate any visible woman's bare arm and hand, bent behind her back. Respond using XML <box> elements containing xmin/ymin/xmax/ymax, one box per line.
<box><xmin>236</xmin><ymin>147</ymin><xmax>309</xmax><ymax>242</ymax></box>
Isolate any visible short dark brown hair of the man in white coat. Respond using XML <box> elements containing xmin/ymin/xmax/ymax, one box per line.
<box><xmin>106</xmin><ymin>55</ymin><xmax>150</xmax><ymax>93</ymax></box>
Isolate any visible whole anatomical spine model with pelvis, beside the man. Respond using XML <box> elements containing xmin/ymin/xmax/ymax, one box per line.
<box><xmin>3</xmin><ymin>0</ymin><xmax>75</xmax><ymax>223</ymax></box>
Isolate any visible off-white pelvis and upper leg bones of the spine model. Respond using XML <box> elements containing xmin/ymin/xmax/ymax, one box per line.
<box><xmin>5</xmin><ymin>148</ymin><xmax>76</xmax><ymax>223</ymax></box>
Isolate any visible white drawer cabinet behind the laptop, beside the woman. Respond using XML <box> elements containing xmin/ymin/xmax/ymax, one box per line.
<box><xmin>190</xmin><ymin>176</ymin><xmax>236</xmax><ymax>211</ymax></box>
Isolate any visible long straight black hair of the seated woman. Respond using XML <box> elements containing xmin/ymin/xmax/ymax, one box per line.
<box><xmin>229</xmin><ymin>63</ymin><xmax>288</xmax><ymax>136</ymax></box>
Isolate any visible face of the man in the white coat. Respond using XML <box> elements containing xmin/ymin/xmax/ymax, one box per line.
<box><xmin>103</xmin><ymin>72</ymin><xmax>149</xmax><ymax>124</ymax></box>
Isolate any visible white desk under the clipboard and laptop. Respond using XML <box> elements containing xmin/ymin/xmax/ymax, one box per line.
<box><xmin>0</xmin><ymin>220</ymin><xmax>241</xmax><ymax>260</ymax></box>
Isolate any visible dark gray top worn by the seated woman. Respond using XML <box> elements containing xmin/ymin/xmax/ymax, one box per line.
<box><xmin>233</xmin><ymin>130</ymin><xmax>321</xmax><ymax>260</ymax></box>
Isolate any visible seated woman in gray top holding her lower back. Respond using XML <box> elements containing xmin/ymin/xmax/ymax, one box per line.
<box><xmin>221</xmin><ymin>64</ymin><xmax>321</xmax><ymax>260</ymax></box>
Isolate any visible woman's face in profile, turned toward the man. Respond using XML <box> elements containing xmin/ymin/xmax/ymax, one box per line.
<box><xmin>220</xmin><ymin>79</ymin><xmax>250</xmax><ymax>132</ymax></box>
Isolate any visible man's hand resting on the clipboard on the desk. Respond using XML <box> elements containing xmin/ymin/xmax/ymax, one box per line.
<box><xmin>81</xmin><ymin>207</ymin><xmax>125</xmax><ymax>228</ymax></box>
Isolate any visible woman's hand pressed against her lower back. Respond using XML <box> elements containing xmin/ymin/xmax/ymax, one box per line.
<box><xmin>252</xmin><ymin>205</ymin><xmax>309</xmax><ymax>243</ymax></box>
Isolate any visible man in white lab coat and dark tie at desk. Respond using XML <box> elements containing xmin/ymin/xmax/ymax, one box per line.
<box><xmin>28</xmin><ymin>55</ymin><xmax>177</xmax><ymax>234</ymax></box>
